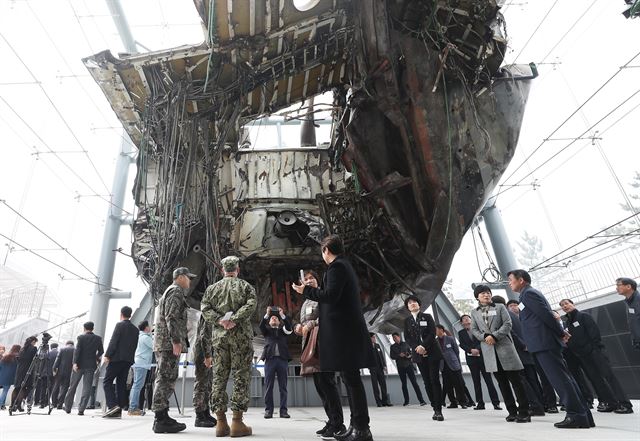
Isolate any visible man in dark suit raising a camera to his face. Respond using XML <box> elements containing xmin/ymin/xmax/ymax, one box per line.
<box><xmin>260</xmin><ymin>306</ymin><xmax>293</xmax><ymax>418</ymax></box>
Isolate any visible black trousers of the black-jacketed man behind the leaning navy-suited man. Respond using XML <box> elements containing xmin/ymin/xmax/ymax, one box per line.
<box><xmin>578</xmin><ymin>350</ymin><xmax>632</xmax><ymax>408</ymax></box>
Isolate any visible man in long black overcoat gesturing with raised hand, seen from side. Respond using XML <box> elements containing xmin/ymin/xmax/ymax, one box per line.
<box><xmin>293</xmin><ymin>235</ymin><xmax>374</xmax><ymax>441</ymax></box>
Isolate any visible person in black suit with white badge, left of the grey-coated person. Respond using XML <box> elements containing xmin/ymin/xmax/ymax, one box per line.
<box><xmin>404</xmin><ymin>295</ymin><xmax>444</xmax><ymax>421</ymax></box>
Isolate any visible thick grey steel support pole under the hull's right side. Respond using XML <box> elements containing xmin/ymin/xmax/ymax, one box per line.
<box><xmin>480</xmin><ymin>196</ymin><xmax>519</xmax><ymax>300</ymax></box>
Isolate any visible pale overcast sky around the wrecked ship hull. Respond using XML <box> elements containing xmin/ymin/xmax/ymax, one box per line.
<box><xmin>0</xmin><ymin>0</ymin><xmax>640</xmax><ymax>334</ymax></box>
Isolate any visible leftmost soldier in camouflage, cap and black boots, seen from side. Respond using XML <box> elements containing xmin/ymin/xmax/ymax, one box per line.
<box><xmin>152</xmin><ymin>267</ymin><xmax>197</xmax><ymax>433</ymax></box>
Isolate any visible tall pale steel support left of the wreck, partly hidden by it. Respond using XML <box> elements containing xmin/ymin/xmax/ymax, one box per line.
<box><xmin>89</xmin><ymin>0</ymin><xmax>137</xmax><ymax>337</ymax></box>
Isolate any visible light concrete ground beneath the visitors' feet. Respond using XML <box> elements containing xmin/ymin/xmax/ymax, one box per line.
<box><xmin>0</xmin><ymin>401</ymin><xmax>640</xmax><ymax>441</ymax></box>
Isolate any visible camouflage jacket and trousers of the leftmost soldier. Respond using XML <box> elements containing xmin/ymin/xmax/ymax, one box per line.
<box><xmin>152</xmin><ymin>285</ymin><xmax>188</xmax><ymax>412</ymax></box>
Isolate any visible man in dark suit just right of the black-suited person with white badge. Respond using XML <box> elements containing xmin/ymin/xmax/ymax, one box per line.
<box><xmin>436</xmin><ymin>325</ymin><xmax>467</xmax><ymax>409</ymax></box>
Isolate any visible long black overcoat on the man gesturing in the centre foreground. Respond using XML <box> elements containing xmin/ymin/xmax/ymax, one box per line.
<box><xmin>304</xmin><ymin>256</ymin><xmax>375</xmax><ymax>372</ymax></box>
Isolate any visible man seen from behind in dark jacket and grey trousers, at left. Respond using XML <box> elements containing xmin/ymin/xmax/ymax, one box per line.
<box><xmin>64</xmin><ymin>322</ymin><xmax>104</xmax><ymax>415</ymax></box>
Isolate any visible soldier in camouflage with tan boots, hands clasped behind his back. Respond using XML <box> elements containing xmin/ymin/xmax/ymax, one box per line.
<box><xmin>201</xmin><ymin>256</ymin><xmax>256</xmax><ymax>437</ymax></box>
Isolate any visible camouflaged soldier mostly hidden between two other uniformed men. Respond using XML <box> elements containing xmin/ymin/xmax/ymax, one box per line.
<box><xmin>193</xmin><ymin>315</ymin><xmax>216</xmax><ymax>427</ymax></box>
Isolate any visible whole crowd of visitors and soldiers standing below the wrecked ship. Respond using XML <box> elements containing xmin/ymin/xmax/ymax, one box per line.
<box><xmin>0</xmin><ymin>235</ymin><xmax>640</xmax><ymax>441</ymax></box>
